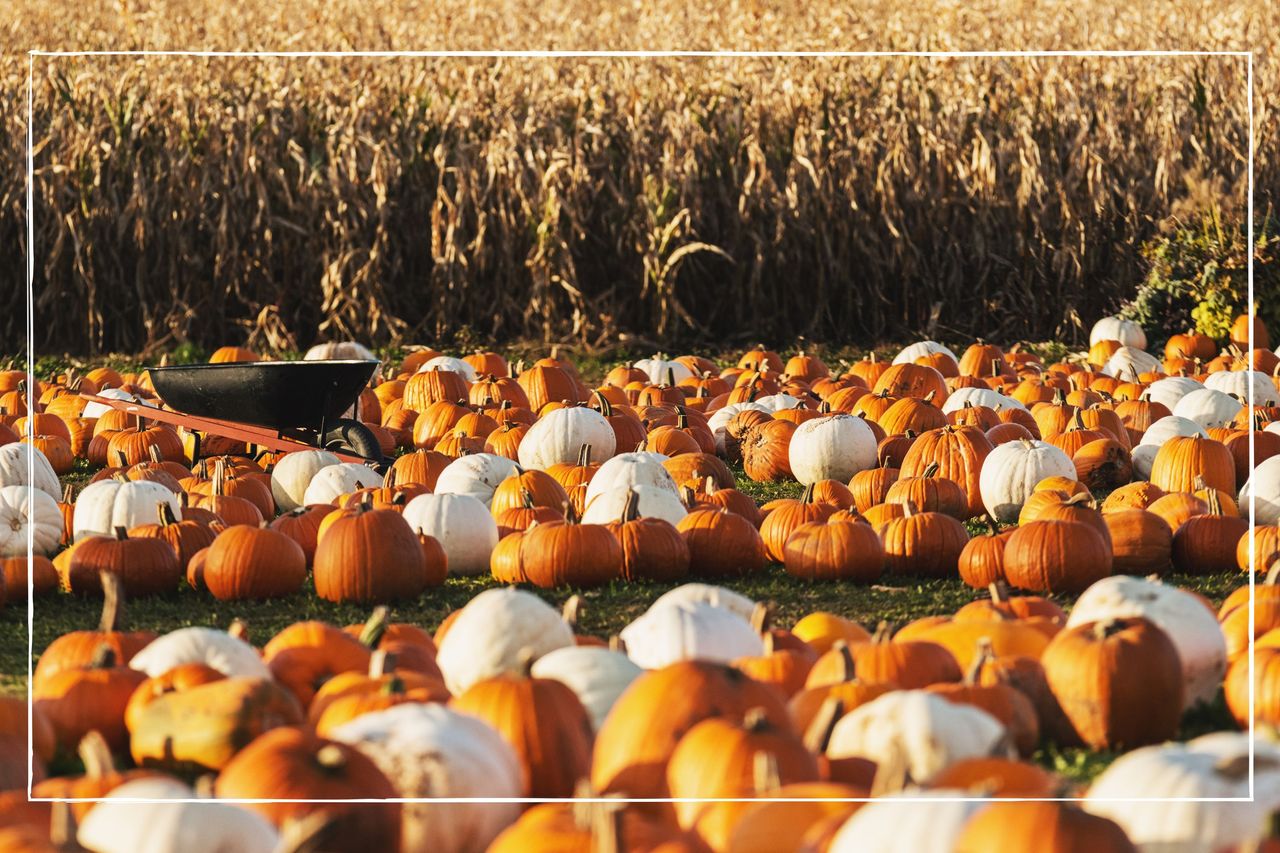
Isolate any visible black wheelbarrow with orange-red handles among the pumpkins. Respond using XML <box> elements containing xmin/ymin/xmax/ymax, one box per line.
<box><xmin>81</xmin><ymin>360</ymin><xmax>384</xmax><ymax>465</ymax></box>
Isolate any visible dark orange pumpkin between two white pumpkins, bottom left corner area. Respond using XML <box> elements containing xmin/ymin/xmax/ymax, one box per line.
<box><xmin>215</xmin><ymin>722</ymin><xmax>399</xmax><ymax>850</ymax></box>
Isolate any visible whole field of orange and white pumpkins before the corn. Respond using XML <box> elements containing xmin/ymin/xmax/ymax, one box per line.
<box><xmin>0</xmin><ymin>307</ymin><xmax>1280</xmax><ymax>853</ymax></box>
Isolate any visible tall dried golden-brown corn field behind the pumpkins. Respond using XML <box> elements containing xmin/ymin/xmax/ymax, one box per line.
<box><xmin>0</xmin><ymin>0</ymin><xmax>1280</xmax><ymax>352</ymax></box>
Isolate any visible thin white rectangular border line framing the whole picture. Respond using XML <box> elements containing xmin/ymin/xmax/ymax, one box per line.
<box><xmin>27</xmin><ymin>50</ymin><xmax>1257</xmax><ymax>804</ymax></box>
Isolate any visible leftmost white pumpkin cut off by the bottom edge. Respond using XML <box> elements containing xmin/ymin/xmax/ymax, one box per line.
<box><xmin>76</xmin><ymin>776</ymin><xmax>280</xmax><ymax>853</ymax></box>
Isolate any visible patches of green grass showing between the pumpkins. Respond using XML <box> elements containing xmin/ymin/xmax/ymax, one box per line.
<box><xmin>0</xmin><ymin>450</ymin><xmax>1245</xmax><ymax>784</ymax></box>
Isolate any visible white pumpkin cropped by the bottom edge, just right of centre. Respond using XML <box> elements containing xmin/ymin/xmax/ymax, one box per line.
<box><xmin>827</xmin><ymin>788</ymin><xmax>986</xmax><ymax>853</ymax></box>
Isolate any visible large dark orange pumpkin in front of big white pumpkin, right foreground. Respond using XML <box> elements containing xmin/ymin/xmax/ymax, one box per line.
<box><xmin>1041</xmin><ymin>616</ymin><xmax>1185</xmax><ymax>749</ymax></box>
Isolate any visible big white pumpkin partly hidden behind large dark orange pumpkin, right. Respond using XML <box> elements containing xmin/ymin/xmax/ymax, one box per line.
<box><xmin>1066</xmin><ymin>575</ymin><xmax>1226</xmax><ymax>708</ymax></box>
